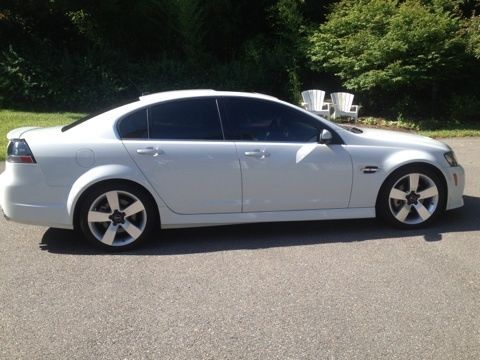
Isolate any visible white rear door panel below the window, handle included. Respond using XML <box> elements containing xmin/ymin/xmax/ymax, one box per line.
<box><xmin>124</xmin><ymin>140</ymin><xmax>242</xmax><ymax>214</ymax></box>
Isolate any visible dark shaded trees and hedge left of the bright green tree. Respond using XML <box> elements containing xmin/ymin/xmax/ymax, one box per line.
<box><xmin>0</xmin><ymin>0</ymin><xmax>312</xmax><ymax>110</ymax></box>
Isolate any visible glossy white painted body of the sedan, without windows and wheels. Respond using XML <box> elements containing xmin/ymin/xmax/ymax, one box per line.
<box><xmin>0</xmin><ymin>90</ymin><xmax>465</xmax><ymax>229</ymax></box>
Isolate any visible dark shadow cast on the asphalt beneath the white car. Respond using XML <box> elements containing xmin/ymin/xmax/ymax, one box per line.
<box><xmin>40</xmin><ymin>196</ymin><xmax>480</xmax><ymax>255</ymax></box>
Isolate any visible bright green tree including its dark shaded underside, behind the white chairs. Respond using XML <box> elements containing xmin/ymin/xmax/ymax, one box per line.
<box><xmin>306</xmin><ymin>0</ymin><xmax>478</xmax><ymax>119</ymax></box>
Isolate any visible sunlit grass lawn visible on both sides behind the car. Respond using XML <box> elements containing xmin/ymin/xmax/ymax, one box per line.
<box><xmin>0</xmin><ymin>109</ymin><xmax>480</xmax><ymax>160</ymax></box>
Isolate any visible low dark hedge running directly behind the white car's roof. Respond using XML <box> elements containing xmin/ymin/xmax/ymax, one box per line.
<box><xmin>0</xmin><ymin>39</ymin><xmax>299</xmax><ymax>112</ymax></box>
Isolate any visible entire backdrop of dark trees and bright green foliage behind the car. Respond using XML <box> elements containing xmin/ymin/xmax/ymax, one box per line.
<box><xmin>0</xmin><ymin>0</ymin><xmax>480</xmax><ymax>120</ymax></box>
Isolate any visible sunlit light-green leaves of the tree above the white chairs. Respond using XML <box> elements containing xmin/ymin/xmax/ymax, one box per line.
<box><xmin>308</xmin><ymin>0</ymin><xmax>463</xmax><ymax>91</ymax></box>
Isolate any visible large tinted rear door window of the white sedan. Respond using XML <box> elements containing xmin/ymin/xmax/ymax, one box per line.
<box><xmin>148</xmin><ymin>99</ymin><xmax>223</xmax><ymax>140</ymax></box>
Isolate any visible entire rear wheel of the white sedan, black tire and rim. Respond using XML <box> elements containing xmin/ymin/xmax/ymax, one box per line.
<box><xmin>77</xmin><ymin>182</ymin><xmax>159</xmax><ymax>251</ymax></box>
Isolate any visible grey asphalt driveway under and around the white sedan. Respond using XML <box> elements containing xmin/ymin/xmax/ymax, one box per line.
<box><xmin>0</xmin><ymin>138</ymin><xmax>480</xmax><ymax>359</ymax></box>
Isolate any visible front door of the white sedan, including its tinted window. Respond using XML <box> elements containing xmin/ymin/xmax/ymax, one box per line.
<box><xmin>222</xmin><ymin>98</ymin><xmax>352</xmax><ymax>212</ymax></box>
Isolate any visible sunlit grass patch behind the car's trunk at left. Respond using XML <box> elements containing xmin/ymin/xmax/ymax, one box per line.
<box><xmin>0</xmin><ymin>109</ymin><xmax>84</xmax><ymax>160</ymax></box>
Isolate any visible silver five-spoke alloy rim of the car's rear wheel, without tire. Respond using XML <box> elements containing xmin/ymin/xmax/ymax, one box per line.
<box><xmin>87</xmin><ymin>191</ymin><xmax>147</xmax><ymax>246</ymax></box>
